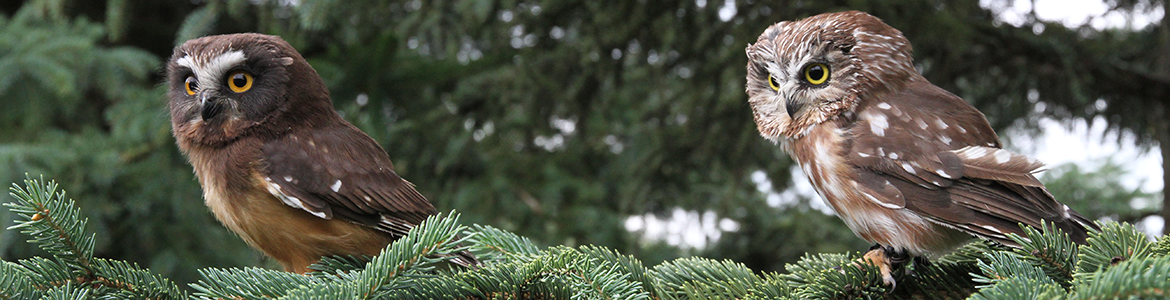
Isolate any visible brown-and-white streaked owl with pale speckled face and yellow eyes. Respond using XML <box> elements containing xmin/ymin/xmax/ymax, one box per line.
<box><xmin>746</xmin><ymin>12</ymin><xmax>1097</xmax><ymax>285</ymax></box>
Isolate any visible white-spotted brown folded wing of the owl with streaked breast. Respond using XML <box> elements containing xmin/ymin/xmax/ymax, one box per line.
<box><xmin>847</xmin><ymin>80</ymin><xmax>1096</xmax><ymax>245</ymax></box>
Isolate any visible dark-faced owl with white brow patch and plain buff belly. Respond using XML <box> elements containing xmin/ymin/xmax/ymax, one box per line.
<box><xmin>165</xmin><ymin>34</ymin><xmax>476</xmax><ymax>273</ymax></box>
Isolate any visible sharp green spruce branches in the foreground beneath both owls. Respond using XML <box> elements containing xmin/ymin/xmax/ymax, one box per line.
<box><xmin>0</xmin><ymin>179</ymin><xmax>1170</xmax><ymax>300</ymax></box>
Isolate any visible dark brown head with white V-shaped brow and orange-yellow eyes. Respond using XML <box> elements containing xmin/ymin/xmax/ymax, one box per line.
<box><xmin>166</xmin><ymin>34</ymin><xmax>336</xmax><ymax>146</ymax></box>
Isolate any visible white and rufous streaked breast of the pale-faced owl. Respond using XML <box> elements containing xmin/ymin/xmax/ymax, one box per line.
<box><xmin>784</xmin><ymin>120</ymin><xmax>954</xmax><ymax>254</ymax></box>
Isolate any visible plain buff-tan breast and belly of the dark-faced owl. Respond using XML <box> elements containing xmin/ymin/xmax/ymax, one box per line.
<box><xmin>187</xmin><ymin>139</ymin><xmax>391</xmax><ymax>273</ymax></box>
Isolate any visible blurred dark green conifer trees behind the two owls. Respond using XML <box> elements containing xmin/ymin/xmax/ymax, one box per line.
<box><xmin>0</xmin><ymin>0</ymin><xmax>1170</xmax><ymax>288</ymax></box>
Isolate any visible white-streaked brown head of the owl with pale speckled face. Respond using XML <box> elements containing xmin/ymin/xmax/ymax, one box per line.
<box><xmin>746</xmin><ymin>11</ymin><xmax>921</xmax><ymax>142</ymax></box>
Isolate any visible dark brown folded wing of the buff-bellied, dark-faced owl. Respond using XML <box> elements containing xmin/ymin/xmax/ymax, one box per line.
<box><xmin>261</xmin><ymin>123</ymin><xmax>436</xmax><ymax>236</ymax></box>
